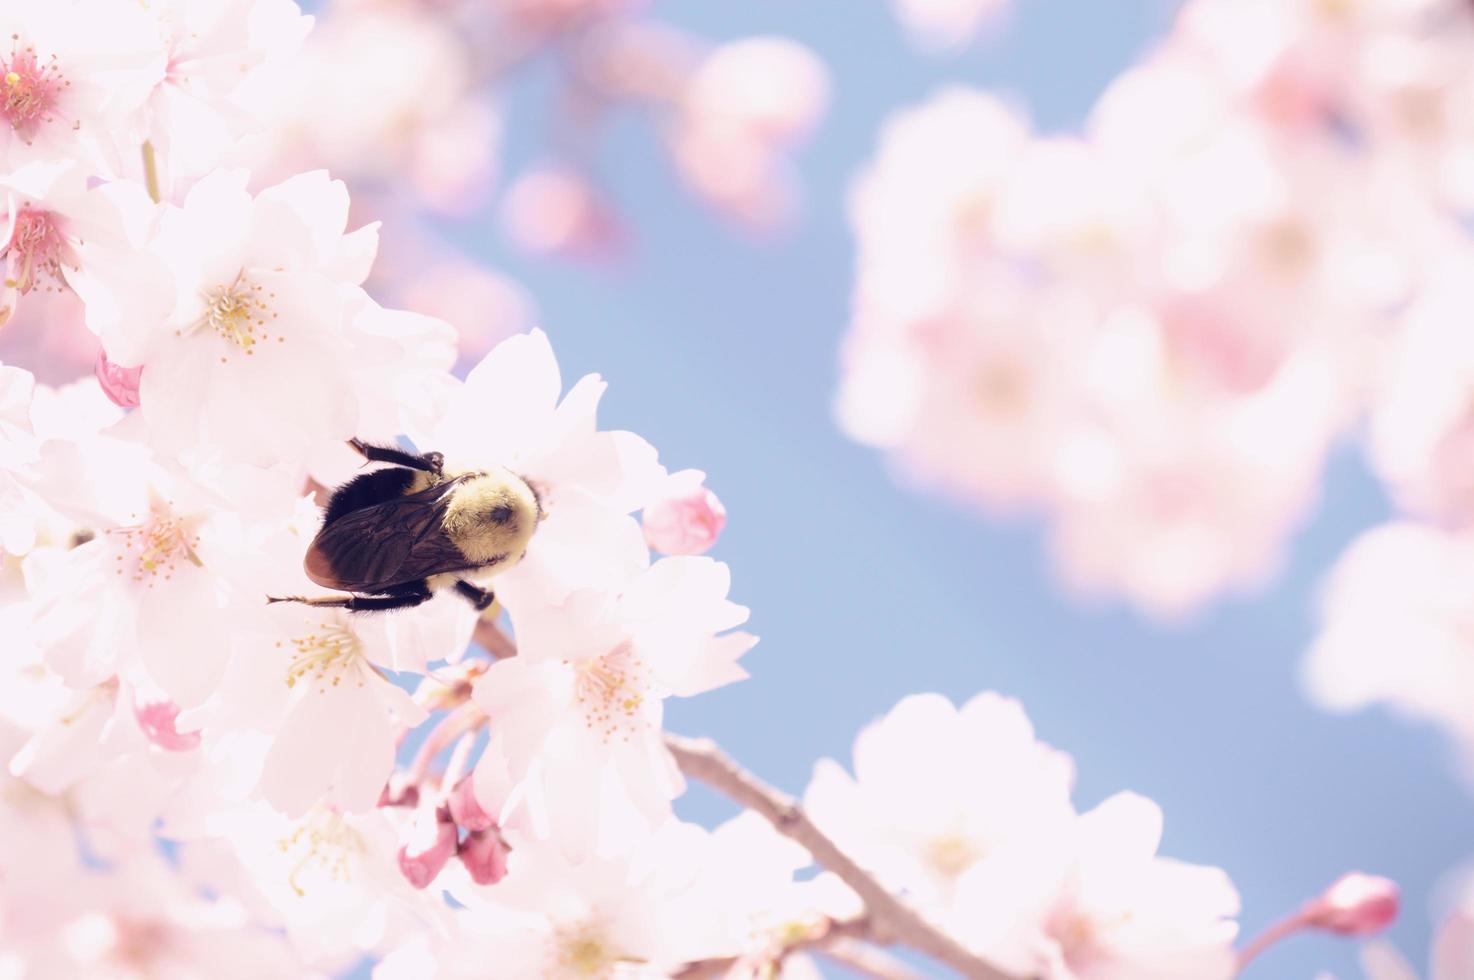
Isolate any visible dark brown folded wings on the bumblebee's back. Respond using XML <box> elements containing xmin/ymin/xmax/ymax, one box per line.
<box><xmin>302</xmin><ymin>477</ymin><xmax>467</xmax><ymax>592</ymax></box>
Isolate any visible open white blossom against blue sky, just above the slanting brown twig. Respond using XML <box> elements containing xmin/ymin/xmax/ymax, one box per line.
<box><xmin>803</xmin><ymin>693</ymin><xmax>1075</xmax><ymax>915</ymax></box>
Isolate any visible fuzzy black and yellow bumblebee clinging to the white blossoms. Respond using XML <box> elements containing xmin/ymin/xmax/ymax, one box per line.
<box><xmin>267</xmin><ymin>439</ymin><xmax>544</xmax><ymax>612</ymax></box>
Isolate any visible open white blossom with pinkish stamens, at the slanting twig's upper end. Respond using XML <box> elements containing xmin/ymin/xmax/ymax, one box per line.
<box><xmin>475</xmin><ymin>557</ymin><xmax>756</xmax><ymax>855</ymax></box>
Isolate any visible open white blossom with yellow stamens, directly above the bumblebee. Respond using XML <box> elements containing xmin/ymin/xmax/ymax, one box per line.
<box><xmin>77</xmin><ymin>172</ymin><xmax>376</xmax><ymax>464</ymax></box>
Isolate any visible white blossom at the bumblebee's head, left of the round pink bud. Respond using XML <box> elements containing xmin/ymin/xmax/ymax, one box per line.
<box><xmin>425</xmin><ymin>330</ymin><xmax>665</xmax><ymax>612</ymax></box>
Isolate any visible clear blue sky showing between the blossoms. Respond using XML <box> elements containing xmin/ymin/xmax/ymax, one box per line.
<box><xmin>427</xmin><ymin>0</ymin><xmax>1474</xmax><ymax>980</ymax></box>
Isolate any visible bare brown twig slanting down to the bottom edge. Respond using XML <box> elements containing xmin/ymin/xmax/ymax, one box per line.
<box><xmin>665</xmin><ymin>734</ymin><xmax>1014</xmax><ymax>980</ymax></box>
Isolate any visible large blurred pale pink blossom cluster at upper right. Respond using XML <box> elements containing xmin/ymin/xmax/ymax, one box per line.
<box><xmin>837</xmin><ymin>0</ymin><xmax>1474</xmax><ymax>616</ymax></box>
